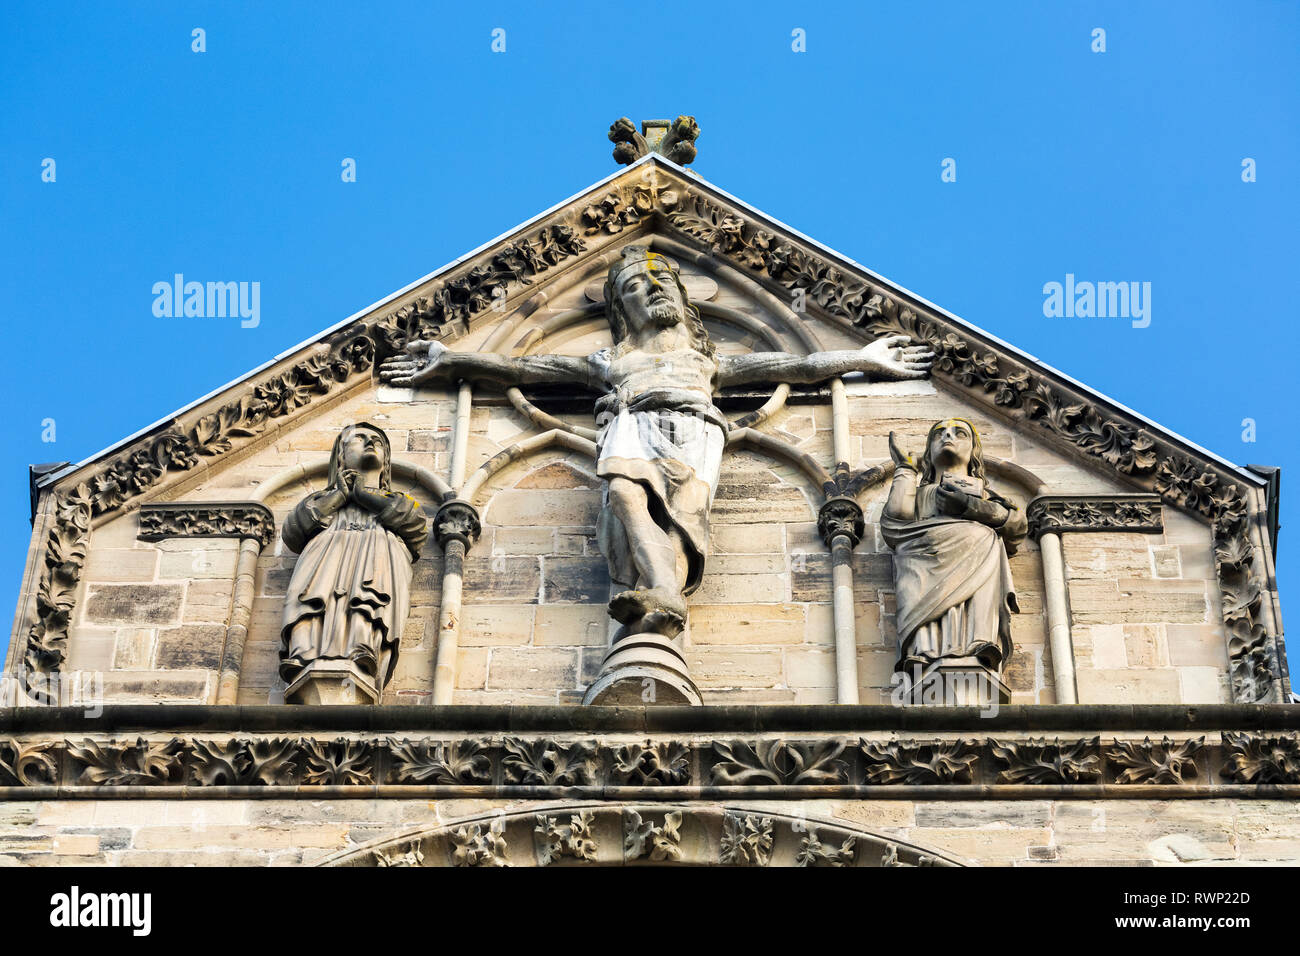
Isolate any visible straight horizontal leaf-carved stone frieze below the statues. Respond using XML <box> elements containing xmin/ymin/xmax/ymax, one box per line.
<box><xmin>0</xmin><ymin>731</ymin><xmax>1300</xmax><ymax>800</ymax></box>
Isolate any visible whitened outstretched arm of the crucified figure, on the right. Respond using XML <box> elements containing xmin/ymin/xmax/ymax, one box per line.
<box><xmin>718</xmin><ymin>336</ymin><xmax>935</xmax><ymax>388</ymax></box>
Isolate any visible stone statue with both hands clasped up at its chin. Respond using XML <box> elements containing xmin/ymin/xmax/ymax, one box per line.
<box><xmin>280</xmin><ymin>421</ymin><xmax>428</xmax><ymax>702</ymax></box>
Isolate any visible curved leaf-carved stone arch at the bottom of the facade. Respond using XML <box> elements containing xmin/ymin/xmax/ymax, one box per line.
<box><xmin>320</xmin><ymin>803</ymin><xmax>946</xmax><ymax>866</ymax></box>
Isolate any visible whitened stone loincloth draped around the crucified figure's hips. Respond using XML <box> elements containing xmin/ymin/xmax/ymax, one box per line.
<box><xmin>595</xmin><ymin>389</ymin><xmax>727</xmax><ymax>594</ymax></box>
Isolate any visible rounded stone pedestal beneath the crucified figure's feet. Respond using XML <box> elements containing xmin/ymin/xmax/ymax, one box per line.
<box><xmin>582</xmin><ymin>632</ymin><xmax>701</xmax><ymax>706</ymax></box>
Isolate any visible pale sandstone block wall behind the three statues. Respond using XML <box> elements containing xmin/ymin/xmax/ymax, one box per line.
<box><xmin>25</xmin><ymin>289</ymin><xmax>1230</xmax><ymax>705</ymax></box>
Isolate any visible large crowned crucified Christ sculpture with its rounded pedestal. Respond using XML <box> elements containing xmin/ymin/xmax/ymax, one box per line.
<box><xmin>380</xmin><ymin>246</ymin><xmax>933</xmax><ymax>704</ymax></box>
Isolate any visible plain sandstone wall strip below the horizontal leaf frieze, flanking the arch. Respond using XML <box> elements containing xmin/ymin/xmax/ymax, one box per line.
<box><xmin>0</xmin><ymin>799</ymin><xmax>1300</xmax><ymax>866</ymax></box>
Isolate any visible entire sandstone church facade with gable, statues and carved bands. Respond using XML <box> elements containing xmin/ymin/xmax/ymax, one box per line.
<box><xmin>0</xmin><ymin>117</ymin><xmax>1300</xmax><ymax>866</ymax></box>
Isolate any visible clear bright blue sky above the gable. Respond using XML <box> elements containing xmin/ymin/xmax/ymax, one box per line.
<box><xmin>0</xmin><ymin>1</ymin><xmax>1300</xmax><ymax>665</ymax></box>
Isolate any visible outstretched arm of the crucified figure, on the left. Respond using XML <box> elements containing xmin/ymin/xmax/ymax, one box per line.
<box><xmin>380</xmin><ymin>339</ymin><xmax>603</xmax><ymax>390</ymax></box>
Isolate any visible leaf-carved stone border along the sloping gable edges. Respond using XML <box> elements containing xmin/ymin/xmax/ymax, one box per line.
<box><xmin>17</xmin><ymin>153</ymin><xmax>1284</xmax><ymax>698</ymax></box>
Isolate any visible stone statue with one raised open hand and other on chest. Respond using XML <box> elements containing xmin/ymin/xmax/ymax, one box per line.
<box><xmin>880</xmin><ymin>419</ymin><xmax>1027</xmax><ymax>675</ymax></box>
